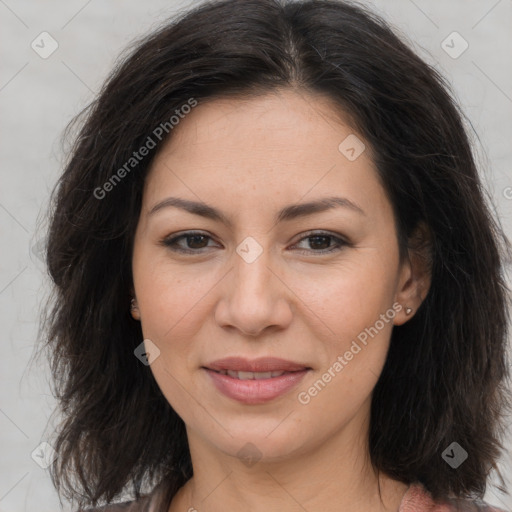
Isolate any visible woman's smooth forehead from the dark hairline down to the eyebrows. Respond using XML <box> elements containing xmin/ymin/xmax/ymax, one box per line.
<box><xmin>144</xmin><ymin>91</ymin><xmax>388</xmax><ymax>224</ymax></box>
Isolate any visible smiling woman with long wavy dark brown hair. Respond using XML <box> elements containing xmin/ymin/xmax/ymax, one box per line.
<box><xmin>41</xmin><ymin>0</ymin><xmax>509</xmax><ymax>512</ymax></box>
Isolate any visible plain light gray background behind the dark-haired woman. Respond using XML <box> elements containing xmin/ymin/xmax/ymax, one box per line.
<box><xmin>0</xmin><ymin>0</ymin><xmax>512</xmax><ymax>512</ymax></box>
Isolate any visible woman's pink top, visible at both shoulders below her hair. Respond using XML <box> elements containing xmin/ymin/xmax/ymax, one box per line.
<box><xmin>79</xmin><ymin>483</ymin><xmax>510</xmax><ymax>512</ymax></box>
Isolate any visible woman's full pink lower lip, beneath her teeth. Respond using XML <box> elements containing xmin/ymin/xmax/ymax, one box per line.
<box><xmin>205</xmin><ymin>368</ymin><xmax>309</xmax><ymax>405</ymax></box>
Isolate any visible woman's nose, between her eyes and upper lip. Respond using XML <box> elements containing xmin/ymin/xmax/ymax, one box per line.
<box><xmin>215</xmin><ymin>246</ymin><xmax>293</xmax><ymax>337</ymax></box>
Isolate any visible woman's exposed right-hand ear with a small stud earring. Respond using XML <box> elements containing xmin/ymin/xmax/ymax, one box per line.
<box><xmin>393</xmin><ymin>222</ymin><xmax>432</xmax><ymax>325</ymax></box>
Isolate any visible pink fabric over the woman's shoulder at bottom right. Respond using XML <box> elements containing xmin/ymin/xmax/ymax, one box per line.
<box><xmin>399</xmin><ymin>483</ymin><xmax>507</xmax><ymax>512</ymax></box>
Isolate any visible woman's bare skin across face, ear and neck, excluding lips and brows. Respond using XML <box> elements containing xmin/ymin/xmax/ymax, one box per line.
<box><xmin>132</xmin><ymin>90</ymin><xmax>429</xmax><ymax>512</ymax></box>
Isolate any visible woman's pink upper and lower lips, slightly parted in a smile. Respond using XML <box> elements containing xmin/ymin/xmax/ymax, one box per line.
<box><xmin>203</xmin><ymin>357</ymin><xmax>311</xmax><ymax>405</ymax></box>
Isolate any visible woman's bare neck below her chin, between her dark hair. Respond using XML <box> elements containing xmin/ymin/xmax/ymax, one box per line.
<box><xmin>169</xmin><ymin>410</ymin><xmax>408</xmax><ymax>512</ymax></box>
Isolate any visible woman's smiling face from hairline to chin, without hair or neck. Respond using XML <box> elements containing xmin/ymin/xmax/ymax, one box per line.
<box><xmin>133</xmin><ymin>91</ymin><xmax>418</xmax><ymax>460</ymax></box>
